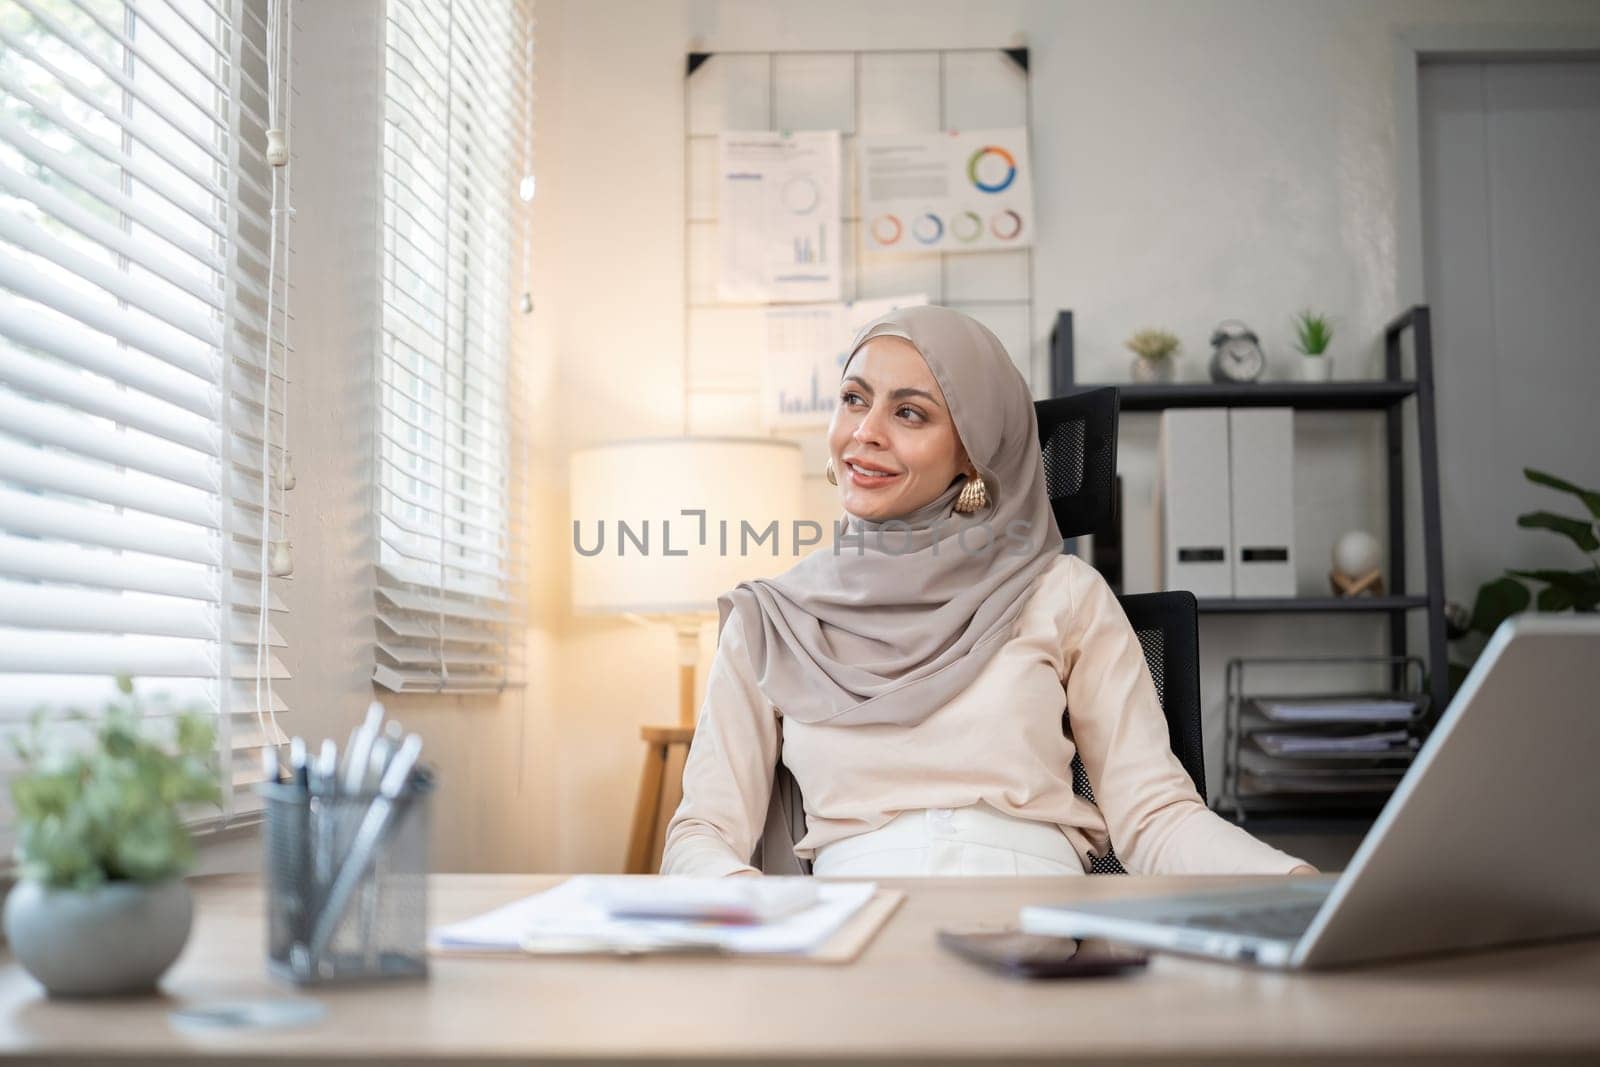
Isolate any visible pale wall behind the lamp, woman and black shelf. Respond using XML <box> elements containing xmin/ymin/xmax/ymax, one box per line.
<box><xmin>275</xmin><ymin>0</ymin><xmax>1600</xmax><ymax>870</ymax></box>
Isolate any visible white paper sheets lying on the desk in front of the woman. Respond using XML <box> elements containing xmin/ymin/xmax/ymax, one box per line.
<box><xmin>429</xmin><ymin>875</ymin><xmax>877</xmax><ymax>955</ymax></box>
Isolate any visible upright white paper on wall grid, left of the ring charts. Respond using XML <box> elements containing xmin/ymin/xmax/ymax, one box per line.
<box><xmin>717</xmin><ymin>130</ymin><xmax>843</xmax><ymax>304</ymax></box>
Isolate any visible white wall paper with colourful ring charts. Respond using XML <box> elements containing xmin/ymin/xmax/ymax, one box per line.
<box><xmin>856</xmin><ymin>128</ymin><xmax>1034</xmax><ymax>253</ymax></box>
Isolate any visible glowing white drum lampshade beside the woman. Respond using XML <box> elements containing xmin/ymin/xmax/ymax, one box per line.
<box><xmin>566</xmin><ymin>437</ymin><xmax>806</xmax><ymax>614</ymax></box>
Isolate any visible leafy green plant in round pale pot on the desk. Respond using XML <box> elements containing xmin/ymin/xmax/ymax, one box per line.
<box><xmin>5</xmin><ymin>678</ymin><xmax>221</xmax><ymax>997</ymax></box>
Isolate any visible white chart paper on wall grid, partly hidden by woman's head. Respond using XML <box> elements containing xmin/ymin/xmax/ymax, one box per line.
<box><xmin>762</xmin><ymin>293</ymin><xmax>928</xmax><ymax>427</ymax></box>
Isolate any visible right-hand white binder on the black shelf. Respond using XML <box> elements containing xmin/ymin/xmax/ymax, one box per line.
<box><xmin>1227</xmin><ymin>408</ymin><xmax>1294</xmax><ymax>597</ymax></box>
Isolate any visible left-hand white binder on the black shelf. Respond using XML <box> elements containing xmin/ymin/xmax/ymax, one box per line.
<box><xmin>1157</xmin><ymin>408</ymin><xmax>1234</xmax><ymax>597</ymax></box>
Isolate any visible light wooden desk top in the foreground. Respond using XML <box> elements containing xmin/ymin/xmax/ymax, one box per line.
<box><xmin>0</xmin><ymin>875</ymin><xmax>1600</xmax><ymax>1067</ymax></box>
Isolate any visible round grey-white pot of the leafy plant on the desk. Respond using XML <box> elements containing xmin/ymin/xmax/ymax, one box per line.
<box><xmin>5</xmin><ymin>878</ymin><xmax>194</xmax><ymax>997</ymax></box>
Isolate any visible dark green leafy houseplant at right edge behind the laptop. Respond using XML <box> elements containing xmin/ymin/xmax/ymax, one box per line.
<box><xmin>1446</xmin><ymin>467</ymin><xmax>1600</xmax><ymax>689</ymax></box>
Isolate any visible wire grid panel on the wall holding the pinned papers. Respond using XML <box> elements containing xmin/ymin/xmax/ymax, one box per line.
<box><xmin>683</xmin><ymin>48</ymin><xmax>1043</xmax><ymax>482</ymax></box>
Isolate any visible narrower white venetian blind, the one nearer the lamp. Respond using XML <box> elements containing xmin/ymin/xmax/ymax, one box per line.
<box><xmin>373</xmin><ymin>0</ymin><xmax>533</xmax><ymax>691</ymax></box>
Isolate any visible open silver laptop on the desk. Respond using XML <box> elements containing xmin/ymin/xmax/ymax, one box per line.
<box><xmin>1021</xmin><ymin>614</ymin><xmax>1600</xmax><ymax>969</ymax></box>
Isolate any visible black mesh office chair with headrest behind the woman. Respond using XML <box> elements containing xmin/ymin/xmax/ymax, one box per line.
<box><xmin>750</xmin><ymin>389</ymin><xmax>1205</xmax><ymax>875</ymax></box>
